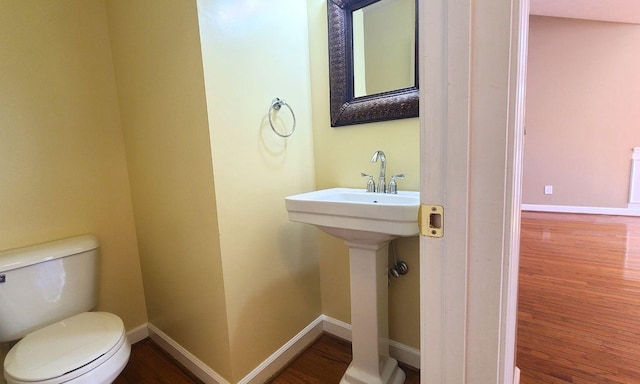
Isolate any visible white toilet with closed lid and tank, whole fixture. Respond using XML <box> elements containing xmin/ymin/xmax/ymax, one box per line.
<box><xmin>0</xmin><ymin>235</ymin><xmax>131</xmax><ymax>384</ymax></box>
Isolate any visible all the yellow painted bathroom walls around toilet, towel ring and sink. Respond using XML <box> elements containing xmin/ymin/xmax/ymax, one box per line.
<box><xmin>0</xmin><ymin>0</ymin><xmax>419</xmax><ymax>382</ymax></box>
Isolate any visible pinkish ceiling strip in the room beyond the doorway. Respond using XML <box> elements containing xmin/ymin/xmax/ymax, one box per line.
<box><xmin>530</xmin><ymin>0</ymin><xmax>640</xmax><ymax>24</ymax></box>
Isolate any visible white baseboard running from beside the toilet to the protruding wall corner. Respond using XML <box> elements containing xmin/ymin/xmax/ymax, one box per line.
<box><xmin>149</xmin><ymin>324</ymin><xmax>229</xmax><ymax>384</ymax></box>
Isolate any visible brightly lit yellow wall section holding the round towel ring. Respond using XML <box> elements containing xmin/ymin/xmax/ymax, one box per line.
<box><xmin>198</xmin><ymin>0</ymin><xmax>321</xmax><ymax>382</ymax></box>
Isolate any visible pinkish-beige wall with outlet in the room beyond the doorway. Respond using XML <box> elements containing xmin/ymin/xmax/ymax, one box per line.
<box><xmin>522</xmin><ymin>16</ymin><xmax>640</xmax><ymax>207</ymax></box>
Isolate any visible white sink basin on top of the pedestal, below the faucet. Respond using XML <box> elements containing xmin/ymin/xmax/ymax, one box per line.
<box><xmin>285</xmin><ymin>188</ymin><xmax>420</xmax><ymax>242</ymax></box>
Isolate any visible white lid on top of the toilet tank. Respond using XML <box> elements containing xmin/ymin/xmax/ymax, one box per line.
<box><xmin>0</xmin><ymin>235</ymin><xmax>98</xmax><ymax>273</ymax></box>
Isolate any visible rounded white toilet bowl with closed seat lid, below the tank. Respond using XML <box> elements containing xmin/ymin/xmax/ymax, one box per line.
<box><xmin>4</xmin><ymin>312</ymin><xmax>130</xmax><ymax>384</ymax></box>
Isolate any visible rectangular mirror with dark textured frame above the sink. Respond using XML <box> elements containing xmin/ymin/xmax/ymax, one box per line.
<box><xmin>327</xmin><ymin>0</ymin><xmax>420</xmax><ymax>127</ymax></box>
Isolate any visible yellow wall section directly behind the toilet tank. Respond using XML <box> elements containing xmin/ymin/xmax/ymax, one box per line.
<box><xmin>0</xmin><ymin>0</ymin><xmax>147</xmax><ymax>378</ymax></box>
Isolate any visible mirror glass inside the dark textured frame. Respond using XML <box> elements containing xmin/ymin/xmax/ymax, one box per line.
<box><xmin>351</xmin><ymin>0</ymin><xmax>416</xmax><ymax>97</ymax></box>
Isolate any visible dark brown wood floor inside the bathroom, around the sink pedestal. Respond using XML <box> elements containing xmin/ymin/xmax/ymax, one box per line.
<box><xmin>114</xmin><ymin>334</ymin><xmax>420</xmax><ymax>384</ymax></box>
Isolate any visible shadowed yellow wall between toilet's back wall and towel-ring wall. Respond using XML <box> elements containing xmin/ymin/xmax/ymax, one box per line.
<box><xmin>106</xmin><ymin>0</ymin><xmax>230</xmax><ymax>377</ymax></box>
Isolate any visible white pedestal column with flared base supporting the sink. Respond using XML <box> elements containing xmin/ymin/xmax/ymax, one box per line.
<box><xmin>340</xmin><ymin>241</ymin><xmax>405</xmax><ymax>384</ymax></box>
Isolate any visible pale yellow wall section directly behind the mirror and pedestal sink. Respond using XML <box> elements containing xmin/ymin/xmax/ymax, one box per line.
<box><xmin>307</xmin><ymin>0</ymin><xmax>420</xmax><ymax>348</ymax></box>
